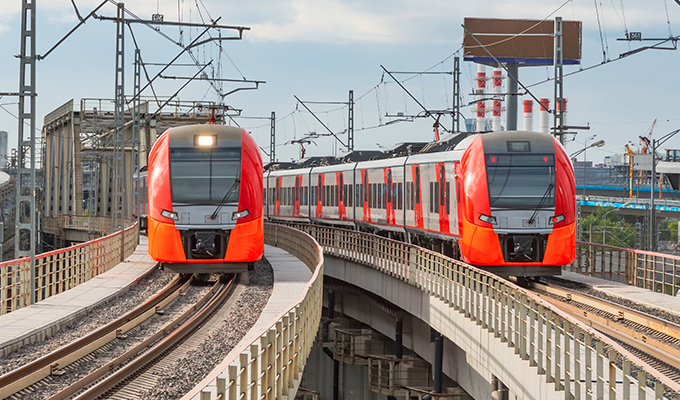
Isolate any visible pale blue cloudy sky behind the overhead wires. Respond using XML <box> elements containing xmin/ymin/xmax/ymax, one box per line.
<box><xmin>0</xmin><ymin>0</ymin><xmax>680</xmax><ymax>163</ymax></box>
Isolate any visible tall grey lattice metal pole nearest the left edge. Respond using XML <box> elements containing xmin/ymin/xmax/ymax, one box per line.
<box><xmin>14</xmin><ymin>0</ymin><xmax>37</xmax><ymax>304</ymax></box>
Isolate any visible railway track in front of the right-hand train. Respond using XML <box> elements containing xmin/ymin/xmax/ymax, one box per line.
<box><xmin>529</xmin><ymin>282</ymin><xmax>680</xmax><ymax>385</ymax></box>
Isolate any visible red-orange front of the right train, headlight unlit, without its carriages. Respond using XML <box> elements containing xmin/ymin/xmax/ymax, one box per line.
<box><xmin>459</xmin><ymin>132</ymin><xmax>576</xmax><ymax>275</ymax></box>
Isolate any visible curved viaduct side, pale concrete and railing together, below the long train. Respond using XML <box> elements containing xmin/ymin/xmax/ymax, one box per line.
<box><xmin>296</xmin><ymin>225</ymin><xmax>680</xmax><ymax>399</ymax></box>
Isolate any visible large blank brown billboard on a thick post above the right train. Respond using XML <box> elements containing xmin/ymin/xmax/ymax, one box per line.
<box><xmin>463</xmin><ymin>18</ymin><xmax>581</xmax><ymax>66</ymax></box>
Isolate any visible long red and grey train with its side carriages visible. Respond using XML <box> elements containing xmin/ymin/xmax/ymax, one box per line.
<box><xmin>265</xmin><ymin>131</ymin><xmax>576</xmax><ymax>276</ymax></box>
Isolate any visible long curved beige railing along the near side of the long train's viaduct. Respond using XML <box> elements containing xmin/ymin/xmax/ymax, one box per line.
<box><xmin>296</xmin><ymin>225</ymin><xmax>680</xmax><ymax>399</ymax></box>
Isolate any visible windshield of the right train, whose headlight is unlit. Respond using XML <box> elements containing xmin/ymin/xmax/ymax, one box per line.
<box><xmin>486</xmin><ymin>154</ymin><xmax>555</xmax><ymax>208</ymax></box>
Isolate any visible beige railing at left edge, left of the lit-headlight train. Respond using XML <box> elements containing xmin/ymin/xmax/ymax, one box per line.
<box><xmin>0</xmin><ymin>223</ymin><xmax>139</xmax><ymax>315</ymax></box>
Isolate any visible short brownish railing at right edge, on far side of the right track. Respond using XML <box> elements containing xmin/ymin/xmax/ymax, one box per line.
<box><xmin>566</xmin><ymin>242</ymin><xmax>680</xmax><ymax>296</ymax></box>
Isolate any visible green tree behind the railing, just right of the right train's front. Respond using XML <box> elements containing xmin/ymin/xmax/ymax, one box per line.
<box><xmin>581</xmin><ymin>207</ymin><xmax>636</xmax><ymax>248</ymax></box>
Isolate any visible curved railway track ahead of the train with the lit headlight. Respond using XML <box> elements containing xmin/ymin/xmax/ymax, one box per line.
<box><xmin>0</xmin><ymin>275</ymin><xmax>237</xmax><ymax>399</ymax></box>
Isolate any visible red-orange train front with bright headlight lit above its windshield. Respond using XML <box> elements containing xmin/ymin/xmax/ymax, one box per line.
<box><xmin>148</xmin><ymin>125</ymin><xmax>264</xmax><ymax>273</ymax></box>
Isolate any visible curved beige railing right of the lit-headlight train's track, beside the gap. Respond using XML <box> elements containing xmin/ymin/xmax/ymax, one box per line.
<box><xmin>183</xmin><ymin>224</ymin><xmax>323</xmax><ymax>400</ymax></box>
